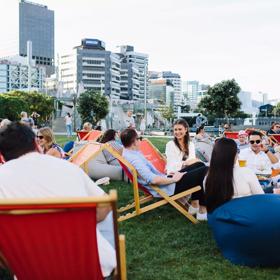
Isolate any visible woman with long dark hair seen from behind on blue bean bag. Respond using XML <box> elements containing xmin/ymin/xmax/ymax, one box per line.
<box><xmin>205</xmin><ymin>138</ymin><xmax>264</xmax><ymax>212</ymax></box>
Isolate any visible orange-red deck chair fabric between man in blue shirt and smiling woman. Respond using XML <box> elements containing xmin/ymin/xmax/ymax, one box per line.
<box><xmin>139</xmin><ymin>138</ymin><xmax>166</xmax><ymax>173</ymax></box>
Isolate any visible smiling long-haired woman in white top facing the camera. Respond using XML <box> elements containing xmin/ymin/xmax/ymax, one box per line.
<box><xmin>165</xmin><ymin>119</ymin><xmax>207</xmax><ymax>220</ymax></box>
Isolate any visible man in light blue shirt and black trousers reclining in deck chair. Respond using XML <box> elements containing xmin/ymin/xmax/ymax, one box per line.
<box><xmin>121</xmin><ymin>128</ymin><xmax>207</xmax><ymax>220</ymax></box>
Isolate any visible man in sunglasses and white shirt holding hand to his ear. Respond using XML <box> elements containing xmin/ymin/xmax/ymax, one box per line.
<box><xmin>239</xmin><ymin>131</ymin><xmax>280</xmax><ymax>174</ymax></box>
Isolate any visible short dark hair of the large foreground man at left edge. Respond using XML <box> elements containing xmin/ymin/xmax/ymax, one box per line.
<box><xmin>0</xmin><ymin>122</ymin><xmax>36</xmax><ymax>161</ymax></box>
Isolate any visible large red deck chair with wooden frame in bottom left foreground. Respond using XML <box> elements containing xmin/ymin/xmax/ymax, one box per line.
<box><xmin>0</xmin><ymin>191</ymin><xmax>126</xmax><ymax>280</ymax></box>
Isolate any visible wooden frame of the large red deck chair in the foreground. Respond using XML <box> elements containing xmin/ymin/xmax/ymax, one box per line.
<box><xmin>0</xmin><ymin>190</ymin><xmax>127</xmax><ymax>280</ymax></box>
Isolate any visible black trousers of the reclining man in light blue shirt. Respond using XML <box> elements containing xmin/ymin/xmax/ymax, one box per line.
<box><xmin>175</xmin><ymin>162</ymin><xmax>208</xmax><ymax>206</ymax></box>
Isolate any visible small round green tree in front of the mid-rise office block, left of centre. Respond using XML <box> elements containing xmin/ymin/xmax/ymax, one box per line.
<box><xmin>78</xmin><ymin>90</ymin><xmax>109</xmax><ymax>124</ymax></box>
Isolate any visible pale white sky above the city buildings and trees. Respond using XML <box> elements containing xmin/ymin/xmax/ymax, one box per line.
<box><xmin>0</xmin><ymin>0</ymin><xmax>280</xmax><ymax>99</ymax></box>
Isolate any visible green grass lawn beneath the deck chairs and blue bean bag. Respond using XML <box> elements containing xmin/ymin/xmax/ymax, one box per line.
<box><xmin>3</xmin><ymin>136</ymin><xmax>280</xmax><ymax>280</ymax></box>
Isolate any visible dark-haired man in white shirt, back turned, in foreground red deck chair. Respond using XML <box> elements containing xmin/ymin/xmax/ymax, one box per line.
<box><xmin>0</xmin><ymin>123</ymin><xmax>116</xmax><ymax>277</ymax></box>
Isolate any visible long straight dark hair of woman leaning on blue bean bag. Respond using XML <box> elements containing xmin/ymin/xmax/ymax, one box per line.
<box><xmin>205</xmin><ymin>138</ymin><xmax>237</xmax><ymax>213</ymax></box>
